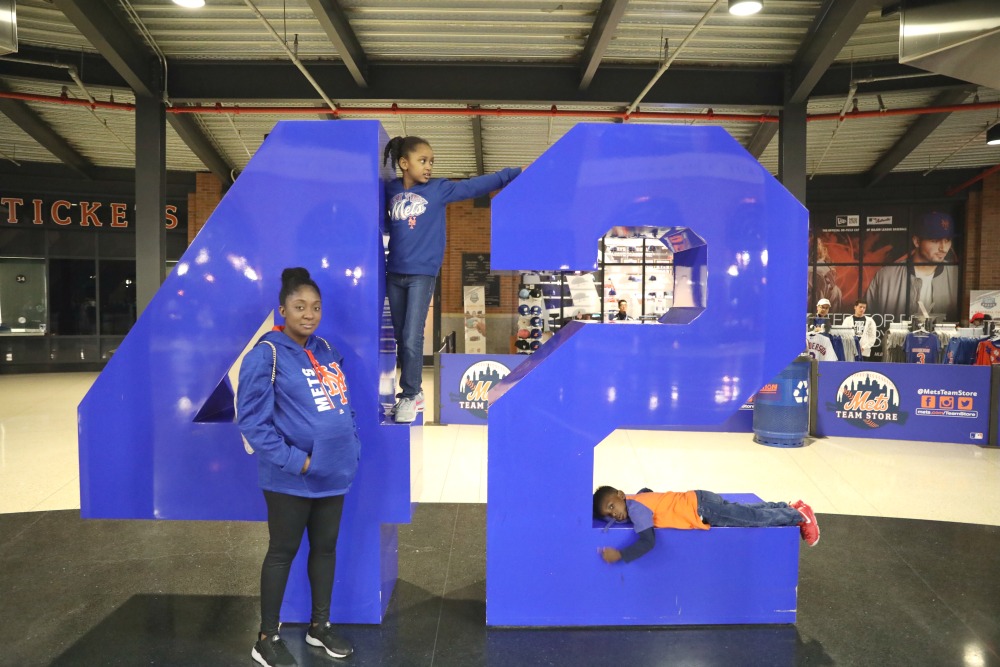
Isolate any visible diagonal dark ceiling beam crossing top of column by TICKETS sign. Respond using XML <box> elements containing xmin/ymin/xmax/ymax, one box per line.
<box><xmin>53</xmin><ymin>0</ymin><xmax>232</xmax><ymax>183</ymax></box>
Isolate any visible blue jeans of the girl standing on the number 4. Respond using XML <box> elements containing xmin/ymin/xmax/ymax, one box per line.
<box><xmin>385</xmin><ymin>273</ymin><xmax>437</xmax><ymax>398</ymax></box>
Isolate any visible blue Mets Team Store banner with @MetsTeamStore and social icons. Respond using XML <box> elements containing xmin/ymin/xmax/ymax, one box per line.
<box><xmin>816</xmin><ymin>362</ymin><xmax>990</xmax><ymax>445</ymax></box>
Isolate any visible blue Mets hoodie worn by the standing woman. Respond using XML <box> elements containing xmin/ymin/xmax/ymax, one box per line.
<box><xmin>236</xmin><ymin>331</ymin><xmax>361</xmax><ymax>498</ymax></box>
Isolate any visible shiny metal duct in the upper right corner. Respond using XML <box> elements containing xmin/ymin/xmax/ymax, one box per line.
<box><xmin>899</xmin><ymin>0</ymin><xmax>1000</xmax><ymax>89</ymax></box>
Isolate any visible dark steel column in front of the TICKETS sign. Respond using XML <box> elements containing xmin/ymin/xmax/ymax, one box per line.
<box><xmin>135</xmin><ymin>94</ymin><xmax>167</xmax><ymax>315</ymax></box>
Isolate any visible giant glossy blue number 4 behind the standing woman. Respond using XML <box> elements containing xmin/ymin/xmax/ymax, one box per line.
<box><xmin>79</xmin><ymin>121</ymin><xmax>410</xmax><ymax>623</ymax></box>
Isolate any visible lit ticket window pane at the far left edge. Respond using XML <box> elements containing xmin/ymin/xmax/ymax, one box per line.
<box><xmin>0</xmin><ymin>259</ymin><xmax>48</xmax><ymax>334</ymax></box>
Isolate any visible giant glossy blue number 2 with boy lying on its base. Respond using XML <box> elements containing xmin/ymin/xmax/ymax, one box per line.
<box><xmin>486</xmin><ymin>124</ymin><xmax>807</xmax><ymax>625</ymax></box>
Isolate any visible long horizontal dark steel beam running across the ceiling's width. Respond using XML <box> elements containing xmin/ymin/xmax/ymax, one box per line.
<box><xmin>0</xmin><ymin>47</ymin><xmax>968</xmax><ymax>108</ymax></box>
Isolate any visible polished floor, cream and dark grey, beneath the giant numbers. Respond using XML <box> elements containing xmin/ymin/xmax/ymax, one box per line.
<box><xmin>0</xmin><ymin>374</ymin><xmax>1000</xmax><ymax>667</ymax></box>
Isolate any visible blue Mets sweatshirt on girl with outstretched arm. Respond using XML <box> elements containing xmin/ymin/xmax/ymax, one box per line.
<box><xmin>385</xmin><ymin>167</ymin><xmax>521</xmax><ymax>276</ymax></box>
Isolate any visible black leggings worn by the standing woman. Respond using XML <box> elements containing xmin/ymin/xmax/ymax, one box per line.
<box><xmin>260</xmin><ymin>491</ymin><xmax>344</xmax><ymax>636</ymax></box>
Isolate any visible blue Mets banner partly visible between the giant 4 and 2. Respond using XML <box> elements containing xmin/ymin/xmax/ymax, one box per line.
<box><xmin>438</xmin><ymin>354</ymin><xmax>528</xmax><ymax>425</ymax></box>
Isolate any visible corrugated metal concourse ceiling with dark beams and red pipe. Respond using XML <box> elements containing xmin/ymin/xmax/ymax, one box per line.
<box><xmin>0</xmin><ymin>0</ymin><xmax>1000</xmax><ymax>189</ymax></box>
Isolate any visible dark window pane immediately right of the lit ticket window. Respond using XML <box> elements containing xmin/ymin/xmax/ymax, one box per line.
<box><xmin>49</xmin><ymin>259</ymin><xmax>97</xmax><ymax>336</ymax></box>
